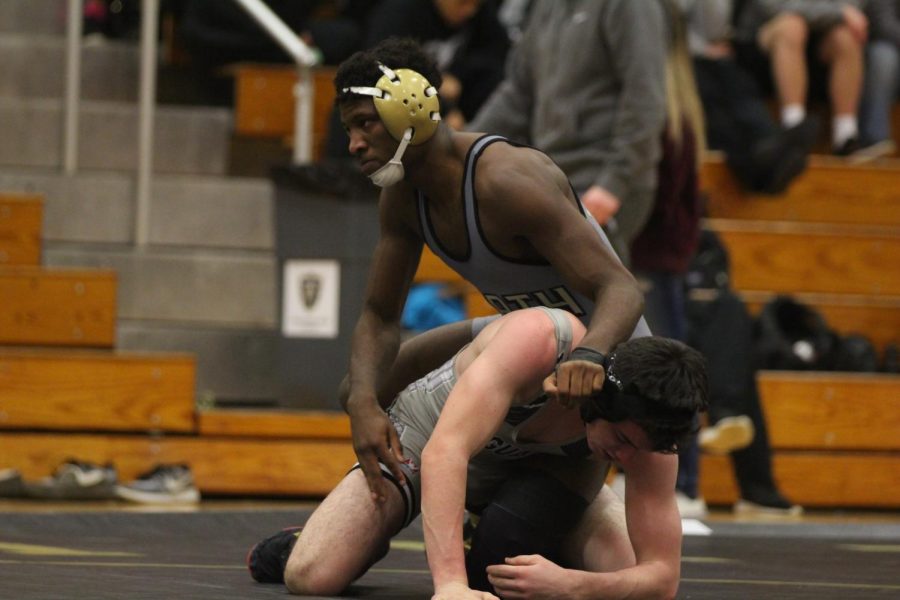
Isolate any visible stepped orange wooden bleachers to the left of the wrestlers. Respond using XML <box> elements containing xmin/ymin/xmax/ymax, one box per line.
<box><xmin>0</xmin><ymin>194</ymin><xmax>353</xmax><ymax>496</ymax></box>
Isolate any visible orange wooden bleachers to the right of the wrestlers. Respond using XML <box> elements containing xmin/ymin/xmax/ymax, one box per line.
<box><xmin>700</xmin><ymin>156</ymin><xmax>900</xmax><ymax>509</ymax></box>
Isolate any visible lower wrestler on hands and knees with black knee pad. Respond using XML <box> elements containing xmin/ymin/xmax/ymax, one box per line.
<box><xmin>253</xmin><ymin>307</ymin><xmax>707</xmax><ymax>600</ymax></box>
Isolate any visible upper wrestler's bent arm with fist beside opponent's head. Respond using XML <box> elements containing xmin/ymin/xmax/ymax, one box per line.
<box><xmin>476</xmin><ymin>147</ymin><xmax>644</xmax><ymax>404</ymax></box>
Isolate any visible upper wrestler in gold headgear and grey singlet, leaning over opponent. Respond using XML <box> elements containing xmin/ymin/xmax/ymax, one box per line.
<box><xmin>335</xmin><ymin>39</ymin><xmax>649</xmax><ymax>501</ymax></box>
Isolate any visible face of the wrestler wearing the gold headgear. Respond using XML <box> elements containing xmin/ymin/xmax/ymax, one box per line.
<box><xmin>340</xmin><ymin>98</ymin><xmax>398</xmax><ymax>175</ymax></box>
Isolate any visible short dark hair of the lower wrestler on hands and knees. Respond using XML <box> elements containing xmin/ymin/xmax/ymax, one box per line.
<box><xmin>582</xmin><ymin>336</ymin><xmax>709</xmax><ymax>453</ymax></box>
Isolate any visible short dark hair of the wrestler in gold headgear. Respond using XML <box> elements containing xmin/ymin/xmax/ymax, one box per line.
<box><xmin>334</xmin><ymin>37</ymin><xmax>443</xmax><ymax>105</ymax></box>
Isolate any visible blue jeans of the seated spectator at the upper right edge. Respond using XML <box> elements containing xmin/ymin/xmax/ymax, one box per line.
<box><xmin>859</xmin><ymin>40</ymin><xmax>900</xmax><ymax>144</ymax></box>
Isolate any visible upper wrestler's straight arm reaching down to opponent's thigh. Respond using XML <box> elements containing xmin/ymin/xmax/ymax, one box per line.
<box><xmin>344</xmin><ymin>184</ymin><xmax>423</xmax><ymax>499</ymax></box>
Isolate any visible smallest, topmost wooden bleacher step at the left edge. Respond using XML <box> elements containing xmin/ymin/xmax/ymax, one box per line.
<box><xmin>0</xmin><ymin>192</ymin><xmax>44</xmax><ymax>266</ymax></box>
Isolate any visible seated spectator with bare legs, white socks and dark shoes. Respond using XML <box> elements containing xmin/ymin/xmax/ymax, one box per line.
<box><xmin>737</xmin><ymin>0</ymin><xmax>868</xmax><ymax>156</ymax></box>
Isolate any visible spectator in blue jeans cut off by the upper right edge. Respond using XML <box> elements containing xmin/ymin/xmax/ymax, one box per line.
<box><xmin>860</xmin><ymin>0</ymin><xmax>900</xmax><ymax>156</ymax></box>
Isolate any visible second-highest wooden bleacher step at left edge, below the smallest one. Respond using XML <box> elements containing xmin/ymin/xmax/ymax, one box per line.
<box><xmin>0</xmin><ymin>266</ymin><xmax>117</xmax><ymax>348</ymax></box>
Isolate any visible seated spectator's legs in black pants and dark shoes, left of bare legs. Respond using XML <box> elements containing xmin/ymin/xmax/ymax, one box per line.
<box><xmin>679</xmin><ymin>0</ymin><xmax>819</xmax><ymax>194</ymax></box>
